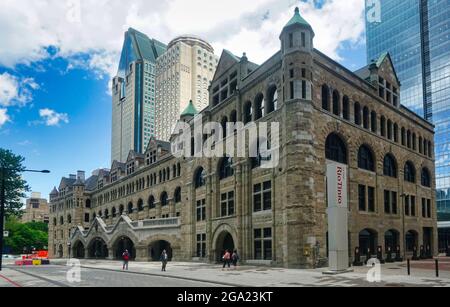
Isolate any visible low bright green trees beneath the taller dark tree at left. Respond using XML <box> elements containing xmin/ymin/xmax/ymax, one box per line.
<box><xmin>5</xmin><ymin>216</ymin><xmax>48</xmax><ymax>254</ymax></box>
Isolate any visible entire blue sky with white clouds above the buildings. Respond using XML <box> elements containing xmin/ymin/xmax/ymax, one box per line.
<box><xmin>0</xmin><ymin>0</ymin><xmax>366</xmax><ymax>198</ymax></box>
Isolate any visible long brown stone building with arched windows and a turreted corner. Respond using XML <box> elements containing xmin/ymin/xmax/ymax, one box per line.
<box><xmin>49</xmin><ymin>9</ymin><xmax>437</xmax><ymax>268</ymax></box>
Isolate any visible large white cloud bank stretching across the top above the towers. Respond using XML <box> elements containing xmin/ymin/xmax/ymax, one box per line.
<box><xmin>0</xmin><ymin>0</ymin><xmax>364</xmax><ymax>77</ymax></box>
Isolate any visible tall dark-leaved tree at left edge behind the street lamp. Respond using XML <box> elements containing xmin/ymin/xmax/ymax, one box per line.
<box><xmin>0</xmin><ymin>148</ymin><xmax>30</xmax><ymax>217</ymax></box>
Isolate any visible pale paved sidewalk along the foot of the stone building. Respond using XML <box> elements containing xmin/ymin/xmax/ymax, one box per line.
<box><xmin>48</xmin><ymin>260</ymin><xmax>450</xmax><ymax>287</ymax></box>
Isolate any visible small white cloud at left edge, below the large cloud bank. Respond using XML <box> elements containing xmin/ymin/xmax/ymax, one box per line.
<box><xmin>0</xmin><ymin>72</ymin><xmax>39</xmax><ymax>107</ymax></box>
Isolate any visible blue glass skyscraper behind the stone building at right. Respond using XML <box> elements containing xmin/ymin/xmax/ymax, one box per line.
<box><xmin>366</xmin><ymin>0</ymin><xmax>450</xmax><ymax>219</ymax></box>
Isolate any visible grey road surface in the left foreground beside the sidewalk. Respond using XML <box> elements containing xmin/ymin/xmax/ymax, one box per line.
<box><xmin>0</xmin><ymin>265</ymin><xmax>224</xmax><ymax>288</ymax></box>
